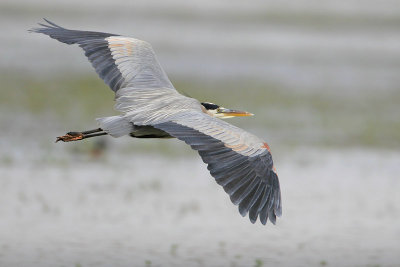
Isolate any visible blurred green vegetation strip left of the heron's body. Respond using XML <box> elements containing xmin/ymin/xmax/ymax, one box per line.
<box><xmin>0</xmin><ymin>74</ymin><xmax>114</xmax><ymax>119</ymax></box>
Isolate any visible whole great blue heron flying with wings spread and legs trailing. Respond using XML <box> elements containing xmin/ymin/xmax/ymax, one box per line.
<box><xmin>30</xmin><ymin>20</ymin><xmax>282</xmax><ymax>224</ymax></box>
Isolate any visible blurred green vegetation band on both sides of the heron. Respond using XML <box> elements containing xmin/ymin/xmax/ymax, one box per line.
<box><xmin>0</xmin><ymin>75</ymin><xmax>400</xmax><ymax>152</ymax></box>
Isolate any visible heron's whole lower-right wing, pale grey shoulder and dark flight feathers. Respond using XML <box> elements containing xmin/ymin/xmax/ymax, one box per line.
<box><xmin>154</xmin><ymin>112</ymin><xmax>282</xmax><ymax>224</ymax></box>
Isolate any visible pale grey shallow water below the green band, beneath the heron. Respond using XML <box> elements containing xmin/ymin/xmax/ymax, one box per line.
<box><xmin>0</xmin><ymin>116</ymin><xmax>400</xmax><ymax>266</ymax></box>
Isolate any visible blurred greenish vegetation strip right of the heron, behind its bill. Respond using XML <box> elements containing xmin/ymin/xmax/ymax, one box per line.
<box><xmin>174</xmin><ymin>78</ymin><xmax>400</xmax><ymax>148</ymax></box>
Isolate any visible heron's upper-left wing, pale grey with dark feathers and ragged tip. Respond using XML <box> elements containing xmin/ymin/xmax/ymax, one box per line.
<box><xmin>31</xmin><ymin>20</ymin><xmax>174</xmax><ymax>92</ymax></box>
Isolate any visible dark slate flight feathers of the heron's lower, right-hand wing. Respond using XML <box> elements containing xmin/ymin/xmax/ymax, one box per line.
<box><xmin>154</xmin><ymin>121</ymin><xmax>282</xmax><ymax>225</ymax></box>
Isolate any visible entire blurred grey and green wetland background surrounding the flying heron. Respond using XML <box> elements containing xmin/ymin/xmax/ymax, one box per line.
<box><xmin>0</xmin><ymin>0</ymin><xmax>400</xmax><ymax>267</ymax></box>
